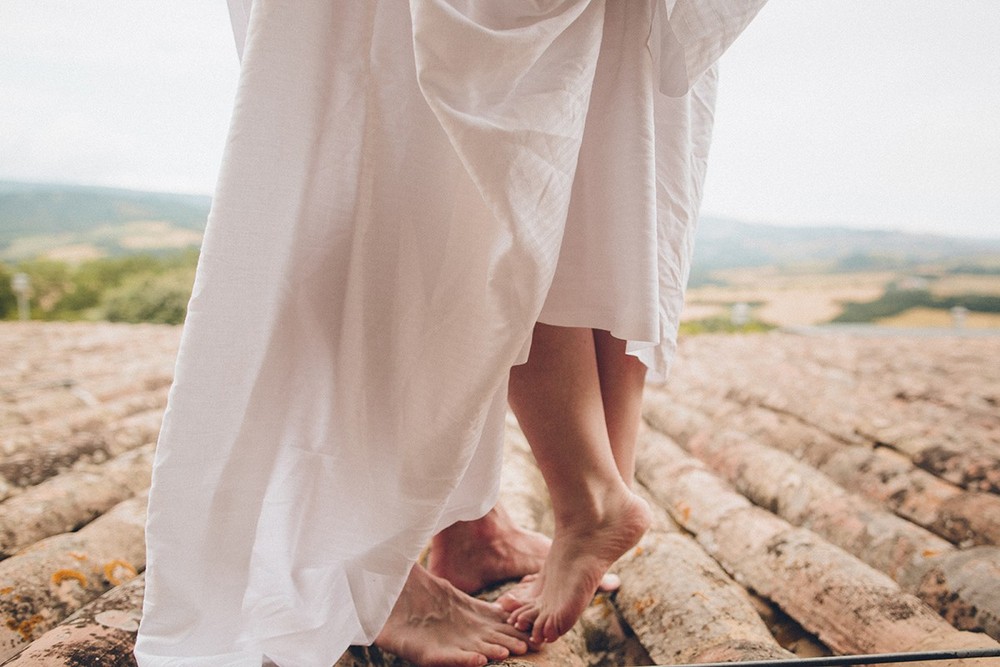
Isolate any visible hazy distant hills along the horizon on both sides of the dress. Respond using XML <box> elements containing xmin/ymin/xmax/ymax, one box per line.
<box><xmin>0</xmin><ymin>181</ymin><xmax>1000</xmax><ymax>274</ymax></box>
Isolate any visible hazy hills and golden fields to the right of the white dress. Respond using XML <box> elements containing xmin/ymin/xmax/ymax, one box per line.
<box><xmin>684</xmin><ymin>218</ymin><xmax>1000</xmax><ymax>331</ymax></box>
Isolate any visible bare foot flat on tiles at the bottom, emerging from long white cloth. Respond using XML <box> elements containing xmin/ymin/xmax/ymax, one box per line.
<box><xmin>375</xmin><ymin>565</ymin><xmax>528</xmax><ymax>667</ymax></box>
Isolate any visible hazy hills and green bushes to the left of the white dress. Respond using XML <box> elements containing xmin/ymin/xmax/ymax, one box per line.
<box><xmin>0</xmin><ymin>181</ymin><xmax>211</xmax><ymax>324</ymax></box>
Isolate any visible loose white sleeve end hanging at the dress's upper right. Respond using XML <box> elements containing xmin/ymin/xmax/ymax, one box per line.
<box><xmin>649</xmin><ymin>0</ymin><xmax>767</xmax><ymax>97</ymax></box>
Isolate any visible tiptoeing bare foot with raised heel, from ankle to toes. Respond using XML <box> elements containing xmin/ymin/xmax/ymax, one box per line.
<box><xmin>499</xmin><ymin>491</ymin><xmax>650</xmax><ymax>643</ymax></box>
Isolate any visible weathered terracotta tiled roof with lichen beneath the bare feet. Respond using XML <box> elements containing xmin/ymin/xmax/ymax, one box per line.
<box><xmin>0</xmin><ymin>323</ymin><xmax>1000</xmax><ymax>667</ymax></box>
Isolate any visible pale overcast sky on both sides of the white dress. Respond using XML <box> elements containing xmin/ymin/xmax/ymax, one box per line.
<box><xmin>0</xmin><ymin>0</ymin><xmax>1000</xmax><ymax>237</ymax></box>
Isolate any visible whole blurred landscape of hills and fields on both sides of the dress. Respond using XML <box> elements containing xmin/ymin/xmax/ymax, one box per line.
<box><xmin>0</xmin><ymin>181</ymin><xmax>1000</xmax><ymax>333</ymax></box>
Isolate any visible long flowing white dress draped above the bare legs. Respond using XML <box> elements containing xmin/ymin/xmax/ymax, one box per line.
<box><xmin>136</xmin><ymin>0</ymin><xmax>763</xmax><ymax>667</ymax></box>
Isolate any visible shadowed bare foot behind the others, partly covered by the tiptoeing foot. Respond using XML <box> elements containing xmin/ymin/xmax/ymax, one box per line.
<box><xmin>428</xmin><ymin>505</ymin><xmax>551</xmax><ymax>593</ymax></box>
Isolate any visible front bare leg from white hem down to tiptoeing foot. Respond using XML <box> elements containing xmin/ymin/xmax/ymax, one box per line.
<box><xmin>503</xmin><ymin>324</ymin><xmax>649</xmax><ymax>642</ymax></box>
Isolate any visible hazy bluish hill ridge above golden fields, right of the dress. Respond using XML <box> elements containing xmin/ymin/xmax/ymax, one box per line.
<box><xmin>692</xmin><ymin>217</ymin><xmax>1000</xmax><ymax>284</ymax></box>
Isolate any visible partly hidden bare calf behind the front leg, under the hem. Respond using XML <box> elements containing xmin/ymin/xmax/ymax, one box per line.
<box><xmin>594</xmin><ymin>329</ymin><xmax>646</xmax><ymax>487</ymax></box>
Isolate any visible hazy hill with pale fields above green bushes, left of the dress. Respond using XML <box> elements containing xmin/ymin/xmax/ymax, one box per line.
<box><xmin>0</xmin><ymin>181</ymin><xmax>211</xmax><ymax>261</ymax></box>
